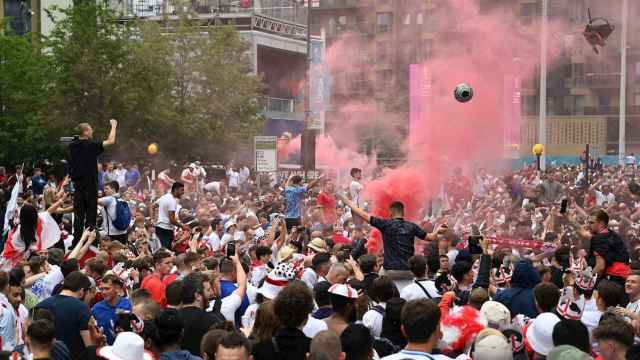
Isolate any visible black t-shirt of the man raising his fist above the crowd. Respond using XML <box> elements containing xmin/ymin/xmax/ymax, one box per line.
<box><xmin>69</xmin><ymin>139</ymin><xmax>104</xmax><ymax>185</ymax></box>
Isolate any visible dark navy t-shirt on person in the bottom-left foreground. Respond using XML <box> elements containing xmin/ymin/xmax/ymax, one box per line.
<box><xmin>36</xmin><ymin>295</ymin><xmax>91</xmax><ymax>359</ymax></box>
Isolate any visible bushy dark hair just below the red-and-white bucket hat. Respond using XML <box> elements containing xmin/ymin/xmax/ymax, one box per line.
<box><xmin>273</xmin><ymin>281</ymin><xmax>313</xmax><ymax>328</ymax></box>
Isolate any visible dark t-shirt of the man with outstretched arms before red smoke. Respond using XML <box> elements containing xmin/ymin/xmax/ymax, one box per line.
<box><xmin>369</xmin><ymin>216</ymin><xmax>427</xmax><ymax>270</ymax></box>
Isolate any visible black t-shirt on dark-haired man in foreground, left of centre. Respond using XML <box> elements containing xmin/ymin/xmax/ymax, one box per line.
<box><xmin>180</xmin><ymin>306</ymin><xmax>225</xmax><ymax>356</ymax></box>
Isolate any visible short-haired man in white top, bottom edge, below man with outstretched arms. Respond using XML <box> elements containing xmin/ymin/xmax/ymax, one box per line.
<box><xmin>382</xmin><ymin>300</ymin><xmax>451</xmax><ymax>360</ymax></box>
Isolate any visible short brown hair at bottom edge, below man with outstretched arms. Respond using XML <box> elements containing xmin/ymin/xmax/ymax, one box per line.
<box><xmin>400</xmin><ymin>299</ymin><xmax>440</xmax><ymax>343</ymax></box>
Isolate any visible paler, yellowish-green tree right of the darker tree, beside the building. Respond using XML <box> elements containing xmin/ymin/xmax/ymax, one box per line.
<box><xmin>162</xmin><ymin>14</ymin><xmax>264</xmax><ymax>161</ymax></box>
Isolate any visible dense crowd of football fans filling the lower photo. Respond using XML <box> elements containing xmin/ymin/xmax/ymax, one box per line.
<box><xmin>0</xmin><ymin>125</ymin><xmax>640</xmax><ymax>360</ymax></box>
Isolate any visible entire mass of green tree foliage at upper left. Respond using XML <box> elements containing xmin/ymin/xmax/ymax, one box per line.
<box><xmin>0</xmin><ymin>2</ymin><xmax>262</xmax><ymax>164</ymax></box>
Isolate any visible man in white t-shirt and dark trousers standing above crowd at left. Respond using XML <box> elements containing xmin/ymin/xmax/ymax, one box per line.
<box><xmin>154</xmin><ymin>181</ymin><xmax>189</xmax><ymax>249</ymax></box>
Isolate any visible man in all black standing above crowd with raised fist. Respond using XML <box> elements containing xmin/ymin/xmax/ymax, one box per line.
<box><xmin>69</xmin><ymin>119</ymin><xmax>118</xmax><ymax>244</ymax></box>
